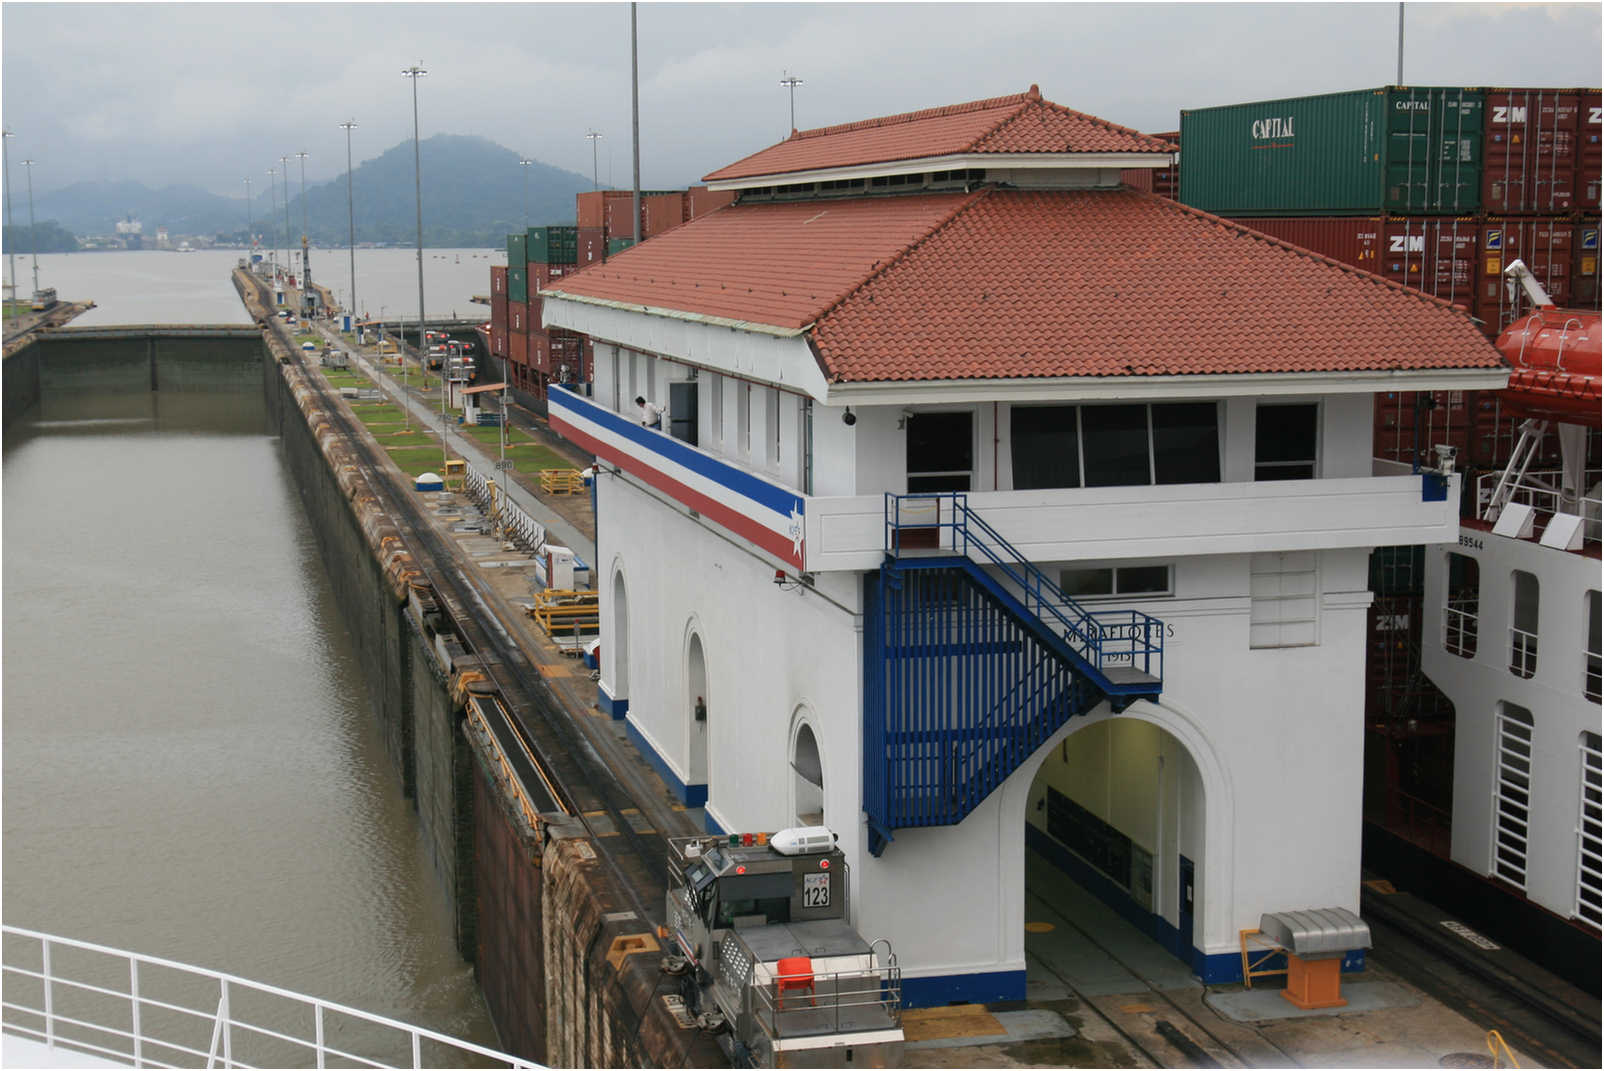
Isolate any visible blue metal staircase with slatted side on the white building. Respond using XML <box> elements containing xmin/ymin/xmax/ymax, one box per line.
<box><xmin>863</xmin><ymin>492</ymin><xmax>1165</xmax><ymax>855</ymax></box>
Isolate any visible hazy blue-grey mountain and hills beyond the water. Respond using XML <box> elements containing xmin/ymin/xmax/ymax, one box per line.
<box><xmin>35</xmin><ymin>135</ymin><xmax>603</xmax><ymax>247</ymax></box>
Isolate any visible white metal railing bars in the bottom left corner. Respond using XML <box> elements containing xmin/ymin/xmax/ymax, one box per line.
<box><xmin>0</xmin><ymin>925</ymin><xmax>541</xmax><ymax>1068</ymax></box>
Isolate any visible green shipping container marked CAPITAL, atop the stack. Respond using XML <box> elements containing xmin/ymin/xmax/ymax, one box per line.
<box><xmin>1181</xmin><ymin>88</ymin><xmax>1484</xmax><ymax>216</ymax></box>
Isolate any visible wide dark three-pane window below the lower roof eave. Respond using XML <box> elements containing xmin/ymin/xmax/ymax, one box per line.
<box><xmin>1009</xmin><ymin>402</ymin><xmax>1219</xmax><ymax>491</ymax></box>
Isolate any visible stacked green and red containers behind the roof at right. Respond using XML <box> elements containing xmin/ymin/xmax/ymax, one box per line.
<box><xmin>1174</xmin><ymin>87</ymin><xmax>1601</xmax><ymax>467</ymax></box>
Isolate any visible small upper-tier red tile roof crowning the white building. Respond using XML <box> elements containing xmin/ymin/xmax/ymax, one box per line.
<box><xmin>703</xmin><ymin>87</ymin><xmax>1174</xmax><ymax>183</ymax></box>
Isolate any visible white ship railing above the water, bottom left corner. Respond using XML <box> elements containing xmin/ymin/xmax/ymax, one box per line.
<box><xmin>0</xmin><ymin>925</ymin><xmax>541</xmax><ymax>1068</ymax></box>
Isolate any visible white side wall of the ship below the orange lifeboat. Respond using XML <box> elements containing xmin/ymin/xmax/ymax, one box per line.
<box><xmin>1421</xmin><ymin>527</ymin><xmax>1599</xmax><ymax>917</ymax></box>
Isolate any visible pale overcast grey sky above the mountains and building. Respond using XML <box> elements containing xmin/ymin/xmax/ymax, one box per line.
<box><xmin>0</xmin><ymin>0</ymin><xmax>1604</xmax><ymax>196</ymax></box>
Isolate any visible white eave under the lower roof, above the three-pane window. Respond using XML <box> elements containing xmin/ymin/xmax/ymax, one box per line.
<box><xmin>829</xmin><ymin>367</ymin><xmax>1509</xmax><ymax>407</ymax></box>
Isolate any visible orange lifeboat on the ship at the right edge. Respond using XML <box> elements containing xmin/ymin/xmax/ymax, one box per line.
<box><xmin>1497</xmin><ymin>305</ymin><xmax>1601</xmax><ymax>428</ymax></box>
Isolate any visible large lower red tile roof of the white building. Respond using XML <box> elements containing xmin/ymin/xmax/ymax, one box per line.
<box><xmin>550</xmin><ymin>188</ymin><xmax>1501</xmax><ymax>382</ymax></box>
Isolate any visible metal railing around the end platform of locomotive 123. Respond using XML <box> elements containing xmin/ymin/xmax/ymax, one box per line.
<box><xmin>747</xmin><ymin>965</ymin><xmax>901</xmax><ymax>1041</ymax></box>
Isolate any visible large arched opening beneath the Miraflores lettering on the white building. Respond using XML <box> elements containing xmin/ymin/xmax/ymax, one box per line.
<box><xmin>1023</xmin><ymin>715</ymin><xmax>1208</xmax><ymax>986</ymax></box>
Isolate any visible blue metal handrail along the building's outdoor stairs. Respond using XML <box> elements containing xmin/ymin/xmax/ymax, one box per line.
<box><xmin>885</xmin><ymin>491</ymin><xmax>1165</xmax><ymax>677</ymax></box>
